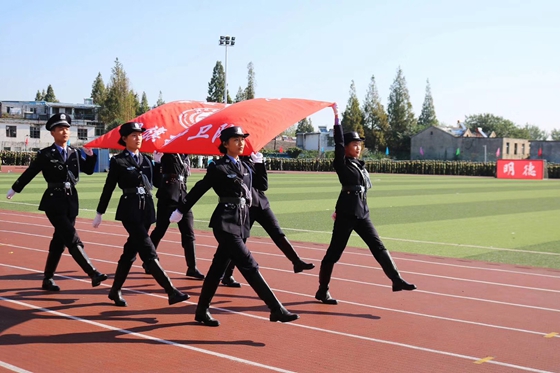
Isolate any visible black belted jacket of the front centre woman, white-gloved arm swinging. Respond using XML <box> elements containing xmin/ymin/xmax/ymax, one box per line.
<box><xmin>179</xmin><ymin>156</ymin><xmax>268</xmax><ymax>238</ymax></box>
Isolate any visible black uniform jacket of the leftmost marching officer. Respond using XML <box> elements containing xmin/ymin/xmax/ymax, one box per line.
<box><xmin>12</xmin><ymin>144</ymin><xmax>97</xmax><ymax>216</ymax></box>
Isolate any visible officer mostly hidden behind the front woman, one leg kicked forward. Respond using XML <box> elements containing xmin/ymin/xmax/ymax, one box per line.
<box><xmin>222</xmin><ymin>152</ymin><xmax>315</xmax><ymax>287</ymax></box>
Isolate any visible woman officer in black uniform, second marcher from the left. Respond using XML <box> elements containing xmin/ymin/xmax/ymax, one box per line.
<box><xmin>93</xmin><ymin>122</ymin><xmax>189</xmax><ymax>307</ymax></box>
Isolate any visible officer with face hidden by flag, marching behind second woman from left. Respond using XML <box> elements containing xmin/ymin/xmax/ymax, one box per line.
<box><xmin>148</xmin><ymin>152</ymin><xmax>204</xmax><ymax>280</ymax></box>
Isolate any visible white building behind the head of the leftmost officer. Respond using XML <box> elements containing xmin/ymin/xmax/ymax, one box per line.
<box><xmin>0</xmin><ymin>98</ymin><xmax>105</xmax><ymax>151</ymax></box>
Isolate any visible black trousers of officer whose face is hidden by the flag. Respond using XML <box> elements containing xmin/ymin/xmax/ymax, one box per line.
<box><xmin>150</xmin><ymin>199</ymin><xmax>196</xmax><ymax>268</ymax></box>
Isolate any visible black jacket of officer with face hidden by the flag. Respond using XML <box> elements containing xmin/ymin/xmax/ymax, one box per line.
<box><xmin>154</xmin><ymin>153</ymin><xmax>189</xmax><ymax>203</ymax></box>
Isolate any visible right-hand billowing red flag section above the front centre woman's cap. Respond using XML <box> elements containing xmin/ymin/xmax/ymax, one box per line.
<box><xmin>160</xmin><ymin>98</ymin><xmax>334</xmax><ymax>155</ymax></box>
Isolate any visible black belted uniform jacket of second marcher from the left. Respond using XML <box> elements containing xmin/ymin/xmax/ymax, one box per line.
<box><xmin>97</xmin><ymin>149</ymin><xmax>159</xmax><ymax>224</ymax></box>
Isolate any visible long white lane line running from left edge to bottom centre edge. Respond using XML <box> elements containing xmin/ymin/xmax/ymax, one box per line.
<box><xmin>0</xmin><ymin>296</ymin><xmax>294</xmax><ymax>373</ymax></box>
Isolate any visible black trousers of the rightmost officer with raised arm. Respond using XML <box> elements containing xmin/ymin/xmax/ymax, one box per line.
<box><xmin>321</xmin><ymin>215</ymin><xmax>400</xmax><ymax>281</ymax></box>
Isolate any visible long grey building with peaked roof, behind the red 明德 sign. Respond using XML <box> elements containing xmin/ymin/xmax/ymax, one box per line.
<box><xmin>410</xmin><ymin>123</ymin><xmax>531</xmax><ymax>162</ymax></box>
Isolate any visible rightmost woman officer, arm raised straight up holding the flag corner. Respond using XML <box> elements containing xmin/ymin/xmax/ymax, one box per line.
<box><xmin>315</xmin><ymin>107</ymin><xmax>416</xmax><ymax>304</ymax></box>
